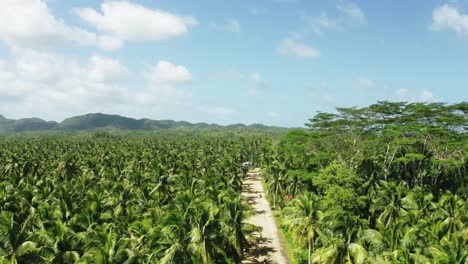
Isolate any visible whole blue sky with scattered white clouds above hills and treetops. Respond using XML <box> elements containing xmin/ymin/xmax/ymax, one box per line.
<box><xmin>0</xmin><ymin>0</ymin><xmax>468</xmax><ymax>126</ymax></box>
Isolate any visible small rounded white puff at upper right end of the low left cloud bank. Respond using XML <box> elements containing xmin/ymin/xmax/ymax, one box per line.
<box><xmin>147</xmin><ymin>60</ymin><xmax>192</xmax><ymax>84</ymax></box>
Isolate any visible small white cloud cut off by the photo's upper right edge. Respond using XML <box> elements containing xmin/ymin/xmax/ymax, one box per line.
<box><xmin>430</xmin><ymin>4</ymin><xmax>468</xmax><ymax>34</ymax></box>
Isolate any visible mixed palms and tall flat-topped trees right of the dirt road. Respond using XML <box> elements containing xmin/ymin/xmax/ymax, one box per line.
<box><xmin>265</xmin><ymin>102</ymin><xmax>468</xmax><ymax>263</ymax></box>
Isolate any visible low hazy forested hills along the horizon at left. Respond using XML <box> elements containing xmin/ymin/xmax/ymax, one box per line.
<box><xmin>0</xmin><ymin>113</ymin><xmax>286</xmax><ymax>134</ymax></box>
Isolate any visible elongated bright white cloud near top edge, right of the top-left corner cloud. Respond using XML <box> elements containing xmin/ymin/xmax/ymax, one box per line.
<box><xmin>75</xmin><ymin>1</ymin><xmax>198</xmax><ymax>41</ymax></box>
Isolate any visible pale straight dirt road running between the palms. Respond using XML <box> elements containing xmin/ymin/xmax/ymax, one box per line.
<box><xmin>242</xmin><ymin>169</ymin><xmax>289</xmax><ymax>264</ymax></box>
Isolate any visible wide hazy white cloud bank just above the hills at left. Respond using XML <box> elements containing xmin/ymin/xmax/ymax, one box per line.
<box><xmin>0</xmin><ymin>48</ymin><xmax>192</xmax><ymax>119</ymax></box>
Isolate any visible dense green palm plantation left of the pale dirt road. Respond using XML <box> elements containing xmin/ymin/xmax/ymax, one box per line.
<box><xmin>0</xmin><ymin>132</ymin><xmax>263</xmax><ymax>264</ymax></box>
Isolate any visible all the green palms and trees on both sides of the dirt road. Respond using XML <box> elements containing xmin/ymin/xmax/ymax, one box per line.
<box><xmin>0</xmin><ymin>102</ymin><xmax>468</xmax><ymax>263</ymax></box>
